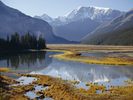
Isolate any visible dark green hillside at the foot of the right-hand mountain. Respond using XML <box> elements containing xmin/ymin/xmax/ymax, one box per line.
<box><xmin>82</xmin><ymin>29</ymin><xmax>133</xmax><ymax>45</ymax></box>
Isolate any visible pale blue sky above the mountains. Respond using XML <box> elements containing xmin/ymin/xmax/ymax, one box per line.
<box><xmin>1</xmin><ymin>0</ymin><xmax>133</xmax><ymax>17</ymax></box>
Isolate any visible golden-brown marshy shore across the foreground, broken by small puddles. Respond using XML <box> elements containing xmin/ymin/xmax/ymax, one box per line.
<box><xmin>0</xmin><ymin>69</ymin><xmax>133</xmax><ymax>100</ymax></box>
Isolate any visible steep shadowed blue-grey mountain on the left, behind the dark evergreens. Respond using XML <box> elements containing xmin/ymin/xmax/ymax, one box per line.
<box><xmin>0</xmin><ymin>1</ymin><xmax>69</xmax><ymax>43</ymax></box>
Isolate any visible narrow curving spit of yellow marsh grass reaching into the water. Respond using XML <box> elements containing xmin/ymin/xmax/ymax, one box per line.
<box><xmin>53</xmin><ymin>50</ymin><xmax>133</xmax><ymax>65</ymax></box>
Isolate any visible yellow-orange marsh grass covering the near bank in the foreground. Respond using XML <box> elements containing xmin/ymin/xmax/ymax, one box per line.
<box><xmin>0</xmin><ymin>75</ymin><xmax>133</xmax><ymax>100</ymax></box>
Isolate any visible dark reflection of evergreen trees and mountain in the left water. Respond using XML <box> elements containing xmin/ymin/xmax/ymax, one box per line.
<box><xmin>0</xmin><ymin>52</ymin><xmax>53</xmax><ymax>71</ymax></box>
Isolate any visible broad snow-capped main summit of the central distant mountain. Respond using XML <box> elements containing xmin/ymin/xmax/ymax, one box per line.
<box><xmin>62</xmin><ymin>6</ymin><xmax>121</xmax><ymax>21</ymax></box>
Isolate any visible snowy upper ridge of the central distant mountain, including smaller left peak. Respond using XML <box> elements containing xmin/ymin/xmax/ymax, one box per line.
<box><xmin>35</xmin><ymin>6</ymin><xmax>124</xmax><ymax>25</ymax></box>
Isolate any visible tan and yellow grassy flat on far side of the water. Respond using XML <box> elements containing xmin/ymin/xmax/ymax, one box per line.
<box><xmin>49</xmin><ymin>45</ymin><xmax>133</xmax><ymax>65</ymax></box>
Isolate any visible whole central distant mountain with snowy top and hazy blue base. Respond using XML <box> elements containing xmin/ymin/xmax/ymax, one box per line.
<box><xmin>35</xmin><ymin>6</ymin><xmax>124</xmax><ymax>42</ymax></box>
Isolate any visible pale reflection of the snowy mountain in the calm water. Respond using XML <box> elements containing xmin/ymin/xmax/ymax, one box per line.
<box><xmin>34</xmin><ymin>59</ymin><xmax>133</xmax><ymax>82</ymax></box>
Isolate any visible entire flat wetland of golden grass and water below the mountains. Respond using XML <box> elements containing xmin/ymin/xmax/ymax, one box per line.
<box><xmin>0</xmin><ymin>45</ymin><xmax>133</xmax><ymax>100</ymax></box>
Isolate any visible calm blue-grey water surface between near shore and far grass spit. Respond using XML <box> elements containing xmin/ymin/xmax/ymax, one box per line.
<box><xmin>0</xmin><ymin>52</ymin><xmax>133</xmax><ymax>87</ymax></box>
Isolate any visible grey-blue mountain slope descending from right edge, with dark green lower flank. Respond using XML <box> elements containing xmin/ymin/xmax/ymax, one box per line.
<box><xmin>82</xmin><ymin>9</ymin><xmax>133</xmax><ymax>45</ymax></box>
